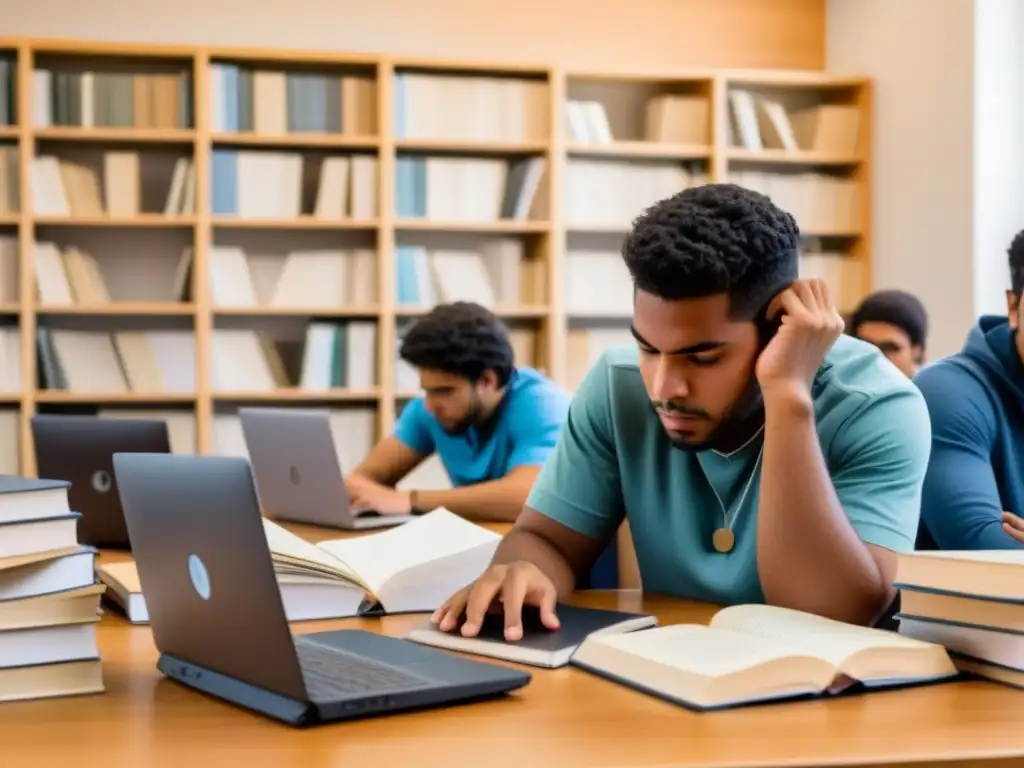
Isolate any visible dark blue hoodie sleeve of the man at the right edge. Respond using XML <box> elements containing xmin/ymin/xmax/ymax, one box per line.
<box><xmin>914</xmin><ymin>362</ymin><xmax>1024</xmax><ymax>550</ymax></box>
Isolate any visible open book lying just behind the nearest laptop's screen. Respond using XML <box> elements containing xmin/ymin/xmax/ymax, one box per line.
<box><xmin>263</xmin><ymin>508</ymin><xmax>501</xmax><ymax>615</ymax></box>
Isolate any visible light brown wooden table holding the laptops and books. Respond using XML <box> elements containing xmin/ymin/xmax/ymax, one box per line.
<box><xmin>6</xmin><ymin>592</ymin><xmax>1024</xmax><ymax>768</ymax></box>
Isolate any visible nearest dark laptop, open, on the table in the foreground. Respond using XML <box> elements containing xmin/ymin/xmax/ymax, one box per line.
<box><xmin>114</xmin><ymin>454</ymin><xmax>530</xmax><ymax>725</ymax></box>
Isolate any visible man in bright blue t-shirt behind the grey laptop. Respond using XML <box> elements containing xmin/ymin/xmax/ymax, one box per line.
<box><xmin>345</xmin><ymin>302</ymin><xmax>569</xmax><ymax>521</ymax></box>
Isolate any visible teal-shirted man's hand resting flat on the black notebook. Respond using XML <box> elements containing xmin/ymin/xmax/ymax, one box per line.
<box><xmin>430</xmin><ymin>560</ymin><xmax>560</xmax><ymax>642</ymax></box>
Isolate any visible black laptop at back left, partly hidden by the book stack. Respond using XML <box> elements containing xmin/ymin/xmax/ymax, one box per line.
<box><xmin>32</xmin><ymin>414</ymin><xmax>171</xmax><ymax>549</ymax></box>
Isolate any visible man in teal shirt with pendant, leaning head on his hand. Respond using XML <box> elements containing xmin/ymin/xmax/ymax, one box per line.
<box><xmin>433</xmin><ymin>184</ymin><xmax>931</xmax><ymax>640</ymax></box>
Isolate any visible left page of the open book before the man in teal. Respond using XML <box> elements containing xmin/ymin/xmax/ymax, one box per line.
<box><xmin>585</xmin><ymin>624</ymin><xmax>811</xmax><ymax>677</ymax></box>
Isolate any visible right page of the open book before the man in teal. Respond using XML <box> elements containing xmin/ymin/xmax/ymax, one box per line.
<box><xmin>710</xmin><ymin>605</ymin><xmax>926</xmax><ymax>668</ymax></box>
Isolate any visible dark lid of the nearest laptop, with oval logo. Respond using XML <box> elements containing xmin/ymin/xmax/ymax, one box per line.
<box><xmin>114</xmin><ymin>454</ymin><xmax>307</xmax><ymax>701</ymax></box>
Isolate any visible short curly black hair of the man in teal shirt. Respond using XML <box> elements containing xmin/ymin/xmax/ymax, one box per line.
<box><xmin>623</xmin><ymin>183</ymin><xmax>800</xmax><ymax>316</ymax></box>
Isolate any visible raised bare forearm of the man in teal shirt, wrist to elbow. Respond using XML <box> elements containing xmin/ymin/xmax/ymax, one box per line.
<box><xmin>757</xmin><ymin>393</ymin><xmax>891</xmax><ymax>624</ymax></box>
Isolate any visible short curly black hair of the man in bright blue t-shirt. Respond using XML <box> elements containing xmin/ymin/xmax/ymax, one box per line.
<box><xmin>398</xmin><ymin>301</ymin><xmax>515</xmax><ymax>387</ymax></box>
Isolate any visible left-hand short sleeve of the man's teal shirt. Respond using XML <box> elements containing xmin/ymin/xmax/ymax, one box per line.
<box><xmin>526</xmin><ymin>357</ymin><xmax>625</xmax><ymax>541</ymax></box>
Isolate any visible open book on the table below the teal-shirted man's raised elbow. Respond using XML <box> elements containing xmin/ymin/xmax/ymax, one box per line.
<box><xmin>570</xmin><ymin>605</ymin><xmax>956</xmax><ymax>711</ymax></box>
